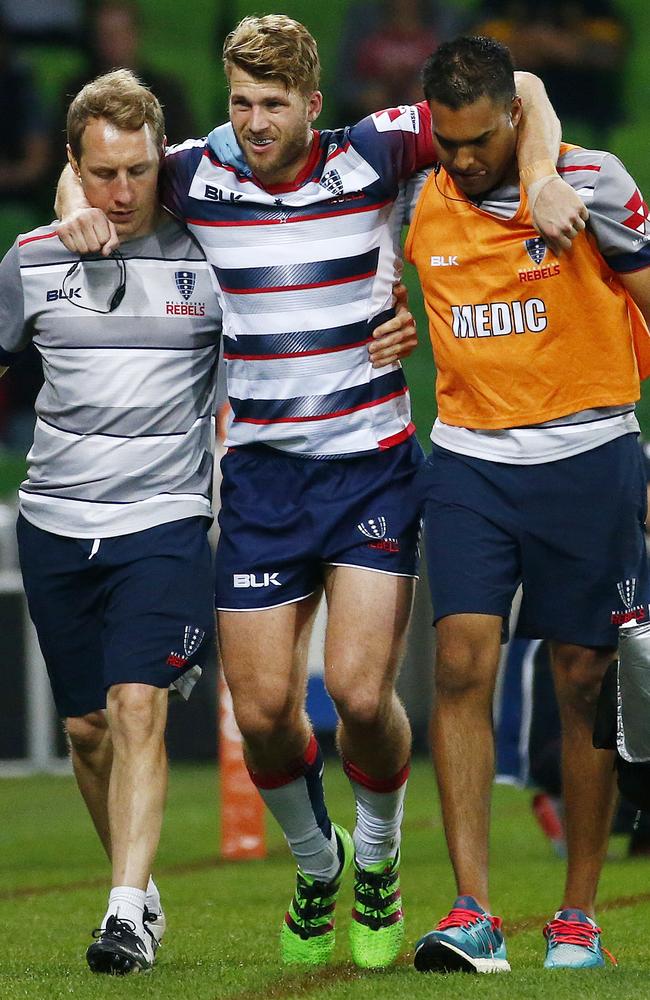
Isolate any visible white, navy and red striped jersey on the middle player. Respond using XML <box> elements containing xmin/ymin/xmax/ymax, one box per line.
<box><xmin>161</xmin><ymin>104</ymin><xmax>434</xmax><ymax>458</ymax></box>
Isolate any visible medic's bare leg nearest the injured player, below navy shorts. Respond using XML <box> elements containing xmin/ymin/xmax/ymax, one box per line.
<box><xmin>431</xmin><ymin>614</ymin><xmax>502</xmax><ymax>912</ymax></box>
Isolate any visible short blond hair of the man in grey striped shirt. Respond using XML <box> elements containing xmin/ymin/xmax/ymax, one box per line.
<box><xmin>67</xmin><ymin>69</ymin><xmax>165</xmax><ymax>160</ymax></box>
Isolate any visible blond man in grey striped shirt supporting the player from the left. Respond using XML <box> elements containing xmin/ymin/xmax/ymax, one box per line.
<box><xmin>0</xmin><ymin>70</ymin><xmax>221</xmax><ymax>974</ymax></box>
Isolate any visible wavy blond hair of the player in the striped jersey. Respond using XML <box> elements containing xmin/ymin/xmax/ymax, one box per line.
<box><xmin>223</xmin><ymin>14</ymin><xmax>320</xmax><ymax>96</ymax></box>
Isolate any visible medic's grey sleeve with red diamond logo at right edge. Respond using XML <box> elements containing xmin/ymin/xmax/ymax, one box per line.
<box><xmin>576</xmin><ymin>153</ymin><xmax>650</xmax><ymax>273</ymax></box>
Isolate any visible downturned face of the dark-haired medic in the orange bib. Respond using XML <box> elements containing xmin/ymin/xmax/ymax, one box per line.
<box><xmin>430</xmin><ymin>96</ymin><xmax>521</xmax><ymax>198</ymax></box>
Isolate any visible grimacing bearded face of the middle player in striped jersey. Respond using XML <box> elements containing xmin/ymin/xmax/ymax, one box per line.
<box><xmin>228</xmin><ymin>66</ymin><xmax>323</xmax><ymax>185</ymax></box>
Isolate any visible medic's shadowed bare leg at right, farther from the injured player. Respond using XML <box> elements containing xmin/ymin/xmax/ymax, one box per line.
<box><xmin>551</xmin><ymin>643</ymin><xmax>615</xmax><ymax>918</ymax></box>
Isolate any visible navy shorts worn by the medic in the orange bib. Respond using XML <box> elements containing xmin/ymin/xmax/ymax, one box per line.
<box><xmin>418</xmin><ymin>434</ymin><xmax>648</xmax><ymax>646</ymax></box>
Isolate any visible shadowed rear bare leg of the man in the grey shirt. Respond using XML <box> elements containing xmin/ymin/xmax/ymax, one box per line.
<box><xmin>65</xmin><ymin>711</ymin><xmax>113</xmax><ymax>860</ymax></box>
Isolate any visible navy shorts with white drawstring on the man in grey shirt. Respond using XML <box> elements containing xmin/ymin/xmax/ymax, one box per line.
<box><xmin>17</xmin><ymin>515</ymin><xmax>214</xmax><ymax>718</ymax></box>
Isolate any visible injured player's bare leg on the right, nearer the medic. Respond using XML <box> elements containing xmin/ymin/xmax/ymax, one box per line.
<box><xmin>325</xmin><ymin>566</ymin><xmax>413</xmax><ymax>778</ymax></box>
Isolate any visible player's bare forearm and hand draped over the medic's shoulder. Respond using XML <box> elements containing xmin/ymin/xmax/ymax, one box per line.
<box><xmin>515</xmin><ymin>73</ymin><xmax>589</xmax><ymax>254</ymax></box>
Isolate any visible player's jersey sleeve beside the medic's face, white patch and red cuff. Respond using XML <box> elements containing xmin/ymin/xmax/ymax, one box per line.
<box><xmin>349</xmin><ymin>101</ymin><xmax>436</xmax><ymax>184</ymax></box>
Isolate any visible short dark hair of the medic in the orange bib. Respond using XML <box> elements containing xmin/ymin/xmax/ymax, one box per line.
<box><xmin>422</xmin><ymin>35</ymin><xmax>516</xmax><ymax>111</ymax></box>
